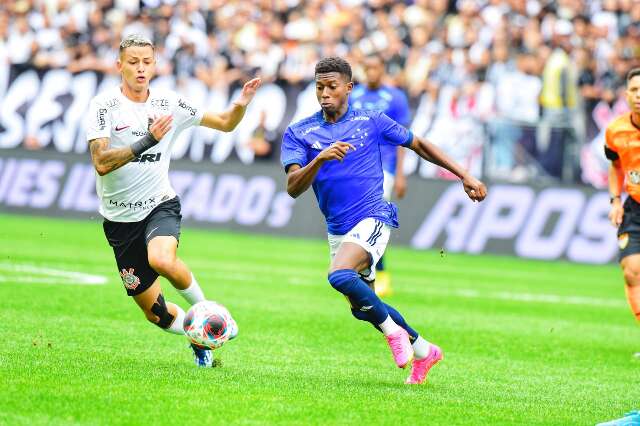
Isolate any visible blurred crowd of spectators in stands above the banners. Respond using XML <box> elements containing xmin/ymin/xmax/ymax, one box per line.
<box><xmin>0</xmin><ymin>0</ymin><xmax>640</xmax><ymax>186</ymax></box>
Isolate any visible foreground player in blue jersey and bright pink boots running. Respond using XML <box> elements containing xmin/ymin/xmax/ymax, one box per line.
<box><xmin>281</xmin><ymin>57</ymin><xmax>486</xmax><ymax>384</ymax></box>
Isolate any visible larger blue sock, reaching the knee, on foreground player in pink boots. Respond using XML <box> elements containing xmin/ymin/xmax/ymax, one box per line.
<box><xmin>329</xmin><ymin>269</ymin><xmax>389</xmax><ymax>325</ymax></box>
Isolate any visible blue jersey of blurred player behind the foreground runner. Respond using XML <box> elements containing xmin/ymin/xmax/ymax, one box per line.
<box><xmin>349</xmin><ymin>84</ymin><xmax>411</xmax><ymax>175</ymax></box>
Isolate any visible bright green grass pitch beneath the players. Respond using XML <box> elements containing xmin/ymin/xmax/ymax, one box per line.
<box><xmin>0</xmin><ymin>215</ymin><xmax>640</xmax><ymax>425</ymax></box>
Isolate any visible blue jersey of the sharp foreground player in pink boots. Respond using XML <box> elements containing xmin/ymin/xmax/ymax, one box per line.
<box><xmin>281</xmin><ymin>107</ymin><xmax>413</xmax><ymax>235</ymax></box>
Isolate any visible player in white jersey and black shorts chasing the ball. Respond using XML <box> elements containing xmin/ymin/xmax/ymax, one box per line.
<box><xmin>87</xmin><ymin>35</ymin><xmax>261</xmax><ymax>366</ymax></box>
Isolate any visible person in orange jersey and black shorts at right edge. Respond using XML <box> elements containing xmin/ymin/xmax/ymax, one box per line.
<box><xmin>604</xmin><ymin>68</ymin><xmax>640</xmax><ymax>357</ymax></box>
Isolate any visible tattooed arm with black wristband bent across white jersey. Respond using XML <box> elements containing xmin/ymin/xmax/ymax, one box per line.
<box><xmin>89</xmin><ymin>115</ymin><xmax>172</xmax><ymax>176</ymax></box>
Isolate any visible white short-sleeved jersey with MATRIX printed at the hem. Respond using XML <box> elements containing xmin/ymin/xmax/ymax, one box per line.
<box><xmin>87</xmin><ymin>87</ymin><xmax>203</xmax><ymax>222</ymax></box>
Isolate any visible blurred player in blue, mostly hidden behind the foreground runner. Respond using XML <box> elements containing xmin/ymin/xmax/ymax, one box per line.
<box><xmin>349</xmin><ymin>55</ymin><xmax>411</xmax><ymax>297</ymax></box>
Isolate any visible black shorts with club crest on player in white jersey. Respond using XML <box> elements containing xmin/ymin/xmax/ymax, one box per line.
<box><xmin>103</xmin><ymin>197</ymin><xmax>182</xmax><ymax>296</ymax></box>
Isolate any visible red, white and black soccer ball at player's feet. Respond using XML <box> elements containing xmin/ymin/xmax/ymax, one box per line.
<box><xmin>183</xmin><ymin>300</ymin><xmax>237</xmax><ymax>349</ymax></box>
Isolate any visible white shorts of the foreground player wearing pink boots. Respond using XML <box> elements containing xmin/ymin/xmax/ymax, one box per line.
<box><xmin>327</xmin><ymin>218</ymin><xmax>391</xmax><ymax>281</ymax></box>
